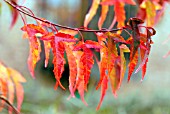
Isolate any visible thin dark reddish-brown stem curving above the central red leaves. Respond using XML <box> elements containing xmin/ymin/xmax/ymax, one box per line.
<box><xmin>4</xmin><ymin>0</ymin><xmax>123</xmax><ymax>32</ymax></box>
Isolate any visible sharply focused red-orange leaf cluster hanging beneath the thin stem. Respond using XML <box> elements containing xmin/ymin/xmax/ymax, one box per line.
<box><xmin>21</xmin><ymin>10</ymin><xmax>155</xmax><ymax>110</ymax></box>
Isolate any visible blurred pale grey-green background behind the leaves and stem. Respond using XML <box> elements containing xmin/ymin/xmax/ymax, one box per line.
<box><xmin>0</xmin><ymin>0</ymin><xmax>170</xmax><ymax>114</ymax></box>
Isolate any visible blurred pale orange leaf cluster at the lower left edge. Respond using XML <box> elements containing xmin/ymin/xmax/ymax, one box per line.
<box><xmin>0</xmin><ymin>62</ymin><xmax>26</xmax><ymax>114</ymax></box>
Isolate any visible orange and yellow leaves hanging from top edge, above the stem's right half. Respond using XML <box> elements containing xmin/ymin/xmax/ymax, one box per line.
<box><xmin>84</xmin><ymin>0</ymin><xmax>169</xmax><ymax>29</ymax></box>
